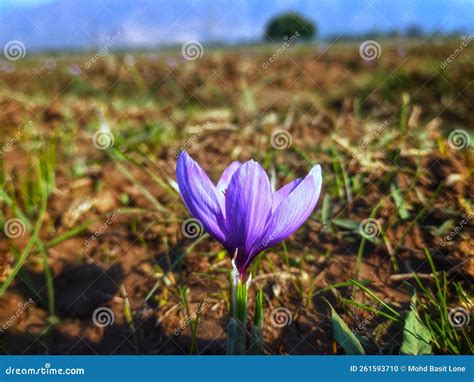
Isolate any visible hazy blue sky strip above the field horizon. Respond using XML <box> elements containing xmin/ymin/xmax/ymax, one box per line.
<box><xmin>0</xmin><ymin>0</ymin><xmax>474</xmax><ymax>49</ymax></box>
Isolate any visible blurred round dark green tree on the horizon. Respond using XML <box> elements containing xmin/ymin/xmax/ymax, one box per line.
<box><xmin>265</xmin><ymin>12</ymin><xmax>316</xmax><ymax>41</ymax></box>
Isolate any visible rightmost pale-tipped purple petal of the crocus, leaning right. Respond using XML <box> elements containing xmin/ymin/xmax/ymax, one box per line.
<box><xmin>254</xmin><ymin>165</ymin><xmax>322</xmax><ymax>253</ymax></box>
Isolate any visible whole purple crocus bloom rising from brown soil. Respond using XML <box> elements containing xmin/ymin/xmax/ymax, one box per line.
<box><xmin>176</xmin><ymin>152</ymin><xmax>322</xmax><ymax>280</ymax></box>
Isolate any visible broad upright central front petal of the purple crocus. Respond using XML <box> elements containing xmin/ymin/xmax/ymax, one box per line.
<box><xmin>225</xmin><ymin>160</ymin><xmax>272</xmax><ymax>273</ymax></box>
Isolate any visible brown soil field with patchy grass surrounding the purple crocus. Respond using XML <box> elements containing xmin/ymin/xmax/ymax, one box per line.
<box><xmin>0</xmin><ymin>40</ymin><xmax>474</xmax><ymax>354</ymax></box>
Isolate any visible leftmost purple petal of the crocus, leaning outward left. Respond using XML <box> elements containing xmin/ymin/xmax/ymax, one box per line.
<box><xmin>176</xmin><ymin>152</ymin><xmax>225</xmax><ymax>243</ymax></box>
